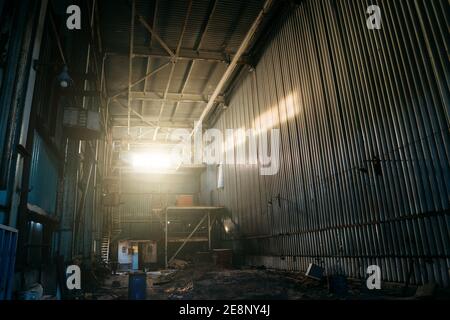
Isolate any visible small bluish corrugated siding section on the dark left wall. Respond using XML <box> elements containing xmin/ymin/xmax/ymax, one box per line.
<box><xmin>28</xmin><ymin>131</ymin><xmax>58</xmax><ymax>214</ymax></box>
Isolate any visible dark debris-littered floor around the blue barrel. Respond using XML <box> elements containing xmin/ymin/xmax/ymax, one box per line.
<box><xmin>91</xmin><ymin>266</ymin><xmax>448</xmax><ymax>300</ymax></box>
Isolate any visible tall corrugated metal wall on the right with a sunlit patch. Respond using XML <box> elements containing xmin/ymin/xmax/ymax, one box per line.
<box><xmin>203</xmin><ymin>0</ymin><xmax>450</xmax><ymax>286</ymax></box>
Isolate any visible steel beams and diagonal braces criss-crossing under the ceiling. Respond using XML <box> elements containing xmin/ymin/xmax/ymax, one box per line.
<box><xmin>106</xmin><ymin>0</ymin><xmax>274</xmax><ymax>145</ymax></box>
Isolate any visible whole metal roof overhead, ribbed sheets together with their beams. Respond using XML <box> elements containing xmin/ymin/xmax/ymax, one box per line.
<box><xmin>99</xmin><ymin>0</ymin><xmax>263</xmax><ymax>140</ymax></box>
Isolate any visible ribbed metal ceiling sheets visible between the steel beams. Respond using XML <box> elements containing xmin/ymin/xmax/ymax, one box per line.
<box><xmin>99</xmin><ymin>0</ymin><xmax>263</xmax><ymax>123</ymax></box>
